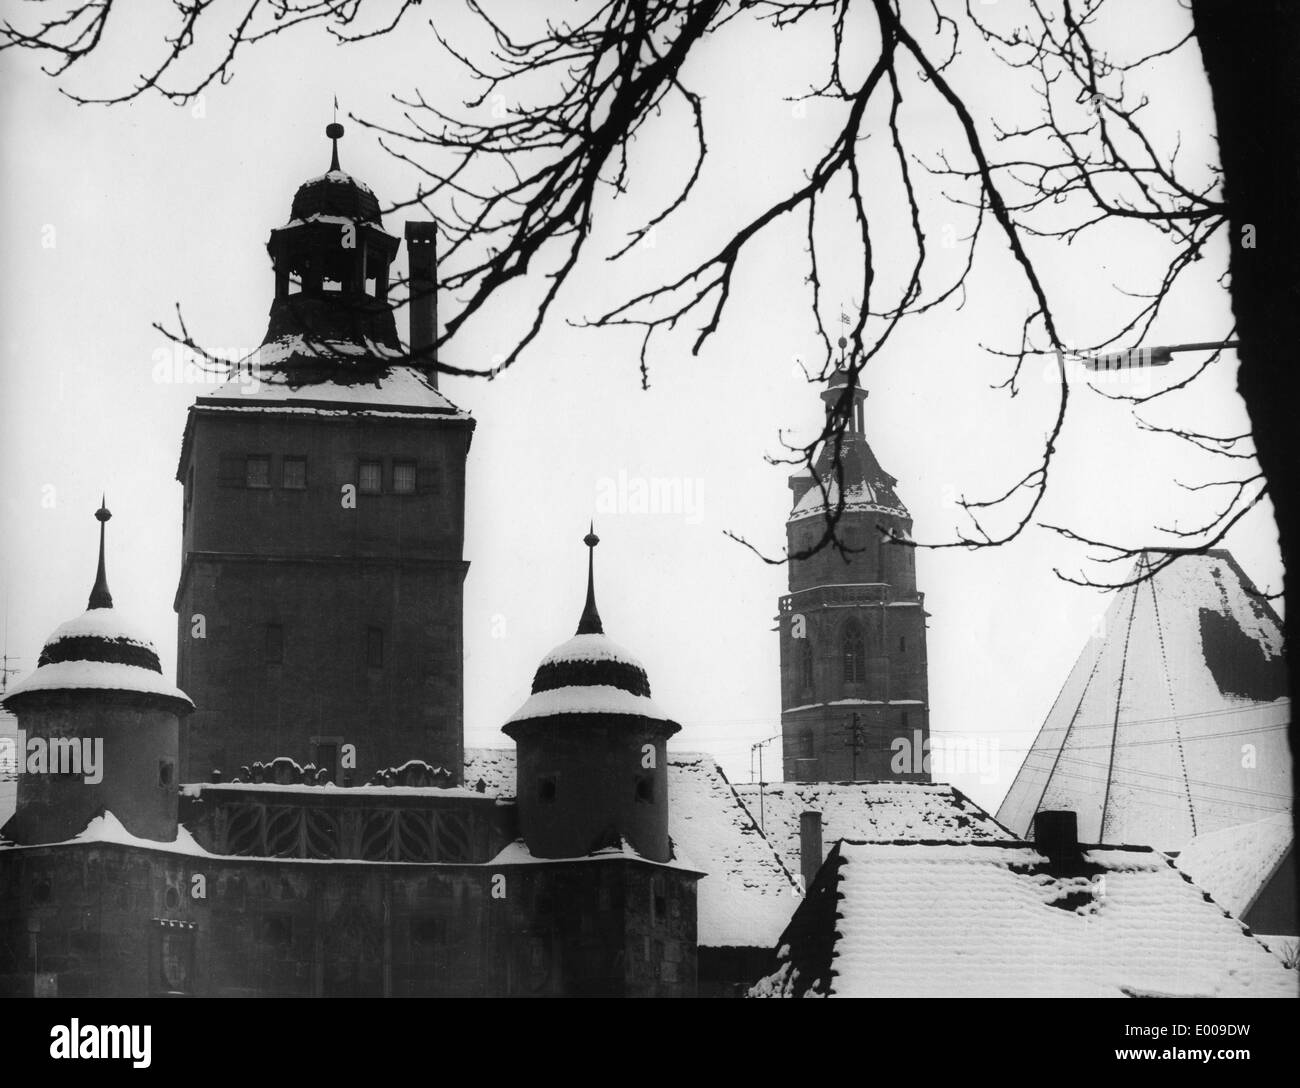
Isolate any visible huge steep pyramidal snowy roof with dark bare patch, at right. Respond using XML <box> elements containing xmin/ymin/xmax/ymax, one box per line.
<box><xmin>997</xmin><ymin>551</ymin><xmax>1291</xmax><ymax>850</ymax></box>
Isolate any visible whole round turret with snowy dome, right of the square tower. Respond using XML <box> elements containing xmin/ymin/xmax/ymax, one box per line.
<box><xmin>502</xmin><ymin>532</ymin><xmax>681</xmax><ymax>862</ymax></box>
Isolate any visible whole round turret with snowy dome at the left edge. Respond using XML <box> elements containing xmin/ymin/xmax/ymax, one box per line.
<box><xmin>4</xmin><ymin>504</ymin><xmax>194</xmax><ymax>844</ymax></box>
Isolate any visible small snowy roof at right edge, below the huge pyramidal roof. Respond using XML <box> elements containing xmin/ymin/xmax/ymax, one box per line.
<box><xmin>1178</xmin><ymin>812</ymin><xmax>1295</xmax><ymax>918</ymax></box>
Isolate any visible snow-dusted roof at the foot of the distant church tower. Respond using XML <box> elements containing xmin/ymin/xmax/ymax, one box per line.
<box><xmin>736</xmin><ymin>781</ymin><xmax>1015</xmax><ymax>872</ymax></box>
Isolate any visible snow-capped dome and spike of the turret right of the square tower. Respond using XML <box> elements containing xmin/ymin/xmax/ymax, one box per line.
<box><xmin>507</xmin><ymin>532</ymin><xmax>679</xmax><ymax>732</ymax></box>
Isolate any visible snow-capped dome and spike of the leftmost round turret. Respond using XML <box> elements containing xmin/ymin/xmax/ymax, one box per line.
<box><xmin>4</xmin><ymin>502</ymin><xmax>194</xmax><ymax>714</ymax></box>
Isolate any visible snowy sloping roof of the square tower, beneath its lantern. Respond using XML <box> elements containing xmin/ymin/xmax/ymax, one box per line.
<box><xmin>195</xmin><ymin>356</ymin><xmax>468</xmax><ymax>419</ymax></box>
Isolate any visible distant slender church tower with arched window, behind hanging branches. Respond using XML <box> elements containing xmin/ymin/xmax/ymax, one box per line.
<box><xmin>779</xmin><ymin>350</ymin><xmax>930</xmax><ymax>781</ymax></box>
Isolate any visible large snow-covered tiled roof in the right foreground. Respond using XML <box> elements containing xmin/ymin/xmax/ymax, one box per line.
<box><xmin>751</xmin><ymin>842</ymin><xmax>1297</xmax><ymax>998</ymax></box>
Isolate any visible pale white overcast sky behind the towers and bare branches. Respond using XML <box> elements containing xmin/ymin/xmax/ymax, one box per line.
<box><xmin>0</xmin><ymin>4</ymin><xmax>1282</xmax><ymax>807</ymax></box>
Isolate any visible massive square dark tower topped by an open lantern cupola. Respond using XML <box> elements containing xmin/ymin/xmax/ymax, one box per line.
<box><xmin>176</xmin><ymin>125</ymin><xmax>473</xmax><ymax>784</ymax></box>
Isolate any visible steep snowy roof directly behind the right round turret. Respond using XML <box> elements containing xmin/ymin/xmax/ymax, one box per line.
<box><xmin>464</xmin><ymin>749</ymin><xmax>800</xmax><ymax>948</ymax></box>
